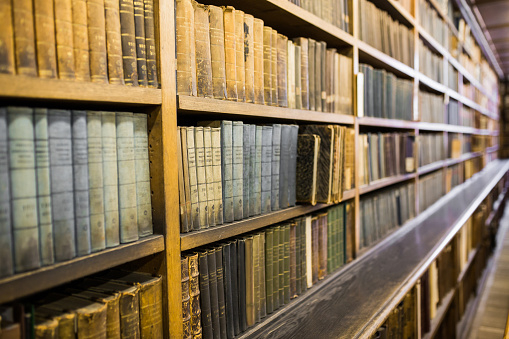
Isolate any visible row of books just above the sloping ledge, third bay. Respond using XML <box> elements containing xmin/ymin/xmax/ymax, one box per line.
<box><xmin>359</xmin><ymin>183</ymin><xmax>415</xmax><ymax>249</ymax></box>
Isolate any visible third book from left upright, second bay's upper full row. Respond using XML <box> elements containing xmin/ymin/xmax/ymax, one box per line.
<box><xmin>209</xmin><ymin>5</ymin><xmax>226</xmax><ymax>99</ymax></box>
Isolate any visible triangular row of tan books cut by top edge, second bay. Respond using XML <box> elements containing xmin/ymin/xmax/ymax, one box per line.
<box><xmin>289</xmin><ymin>0</ymin><xmax>351</xmax><ymax>33</ymax></box>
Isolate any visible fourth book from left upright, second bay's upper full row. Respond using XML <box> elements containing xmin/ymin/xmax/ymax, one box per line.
<box><xmin>223</xmin><ymin>6</ymin><xmax>238</xmax><ymax>101</ymax></box>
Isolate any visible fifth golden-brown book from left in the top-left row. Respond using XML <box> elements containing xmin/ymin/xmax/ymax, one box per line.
<box><xmin>72</xmin><ymin>0</ymin><xmax>90</xmax><ymax>81</ymax></box>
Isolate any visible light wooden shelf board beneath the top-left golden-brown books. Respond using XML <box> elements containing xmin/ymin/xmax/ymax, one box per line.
<box><xmin>0</xmin><ymin>74</ymin><xmax>162</xmax><ymax>105</ymax></box>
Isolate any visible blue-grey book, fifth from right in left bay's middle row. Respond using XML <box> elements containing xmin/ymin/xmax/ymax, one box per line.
<box><xmin>72</xmin><ymin>111</ymin><xmax>92</xmax><ymax>256</ymax></box>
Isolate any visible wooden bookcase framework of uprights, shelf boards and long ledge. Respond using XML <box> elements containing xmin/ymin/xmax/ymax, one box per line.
<box><xmin>0</xmin><ymin>0</ymin><xmax>508</xmax><ymax>338</ymax></box>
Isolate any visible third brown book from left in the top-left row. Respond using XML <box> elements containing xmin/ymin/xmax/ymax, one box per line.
<box><xmin>33</xmin><ymin>0</ymin><xmax>58</xmax><ymax>79</ymax></box>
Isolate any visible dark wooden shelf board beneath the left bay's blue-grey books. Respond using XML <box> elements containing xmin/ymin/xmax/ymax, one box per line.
<box><xmin>0</xmin><ymin>235</ymin><xmax>164</xmax><ymax>304</ymax></box>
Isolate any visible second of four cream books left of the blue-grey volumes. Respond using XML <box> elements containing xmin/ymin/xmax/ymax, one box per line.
<box><xmin>194</xmin><ymin>127</ymin><xmax>209</xmax><ymax>229</ymax></box>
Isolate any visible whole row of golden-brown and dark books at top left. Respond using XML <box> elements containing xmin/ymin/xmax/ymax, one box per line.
<box><xmin>0</xmin><ymin>0</ymin><xmax>159</xmax><ymax>87</ymax></box>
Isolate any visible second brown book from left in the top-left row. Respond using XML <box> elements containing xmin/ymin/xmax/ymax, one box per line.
<box><xmin>12</xmin><ymin>0</ymin><xmax>37</xmax><ymax>77</ymax></box>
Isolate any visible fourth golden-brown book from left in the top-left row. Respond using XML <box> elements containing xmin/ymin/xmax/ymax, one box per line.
<box><xmin>55</xmin><ymin>0</ymin><xmax>76</xmax><ymax>80</ymax></box>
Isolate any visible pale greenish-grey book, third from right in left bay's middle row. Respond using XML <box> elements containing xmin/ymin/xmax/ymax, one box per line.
<box><xmin>101</xmin><ymin>112</ymin><xmax>120</xmax><ymax>247</ymax></box>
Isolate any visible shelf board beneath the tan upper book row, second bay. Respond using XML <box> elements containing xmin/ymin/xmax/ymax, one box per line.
<box><xmin>177</xmin><ymin>95</ymin><xmax>354</xmax><ymax>125</ymax></box>
